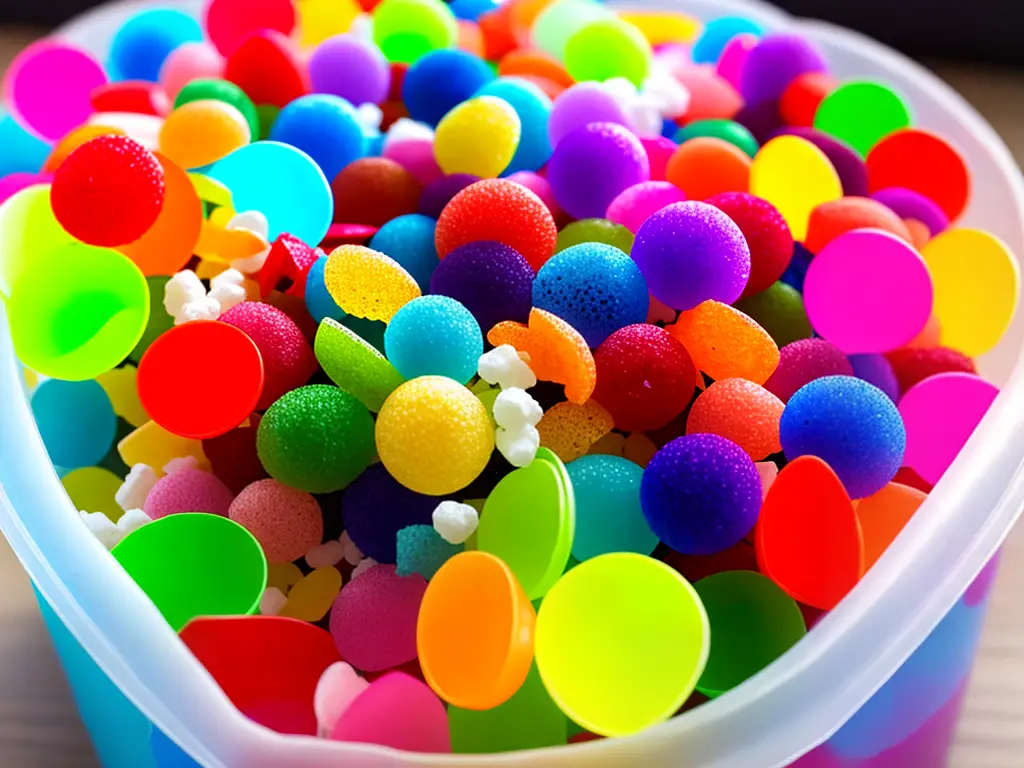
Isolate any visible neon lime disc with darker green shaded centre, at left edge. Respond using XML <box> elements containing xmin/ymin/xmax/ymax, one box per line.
<box><xmin>7</xmin><ymin>243</ymin><xmax>150</xmax><ymax>381</ymax></box>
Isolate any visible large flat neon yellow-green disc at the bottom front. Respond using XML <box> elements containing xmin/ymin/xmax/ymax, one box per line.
<box><xmin>532</xmin><ymin>552</ymin><xmax>710</xmax><ymax>736</ymax></box>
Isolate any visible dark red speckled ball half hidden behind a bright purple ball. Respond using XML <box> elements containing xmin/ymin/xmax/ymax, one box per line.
<box><xmin>705</xmin><ymin>193</ymin><xmax>793</xmax><ymax>299</ymax></box>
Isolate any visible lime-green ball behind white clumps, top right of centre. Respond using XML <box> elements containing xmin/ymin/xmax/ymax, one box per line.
<box><xmin>565</xmin><ymin>18</ymin><xmax>653</xmax><ymax>88</ymax></box>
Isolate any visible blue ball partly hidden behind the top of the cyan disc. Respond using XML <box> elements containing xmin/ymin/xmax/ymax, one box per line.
<box><xmin>270</xmin><ymin>93</ymin><xmax>367</xmax><ymax>181</ymax></box>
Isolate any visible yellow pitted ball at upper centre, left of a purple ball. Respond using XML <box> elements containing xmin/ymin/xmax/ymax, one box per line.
<box><xmin>434</xmin><ymin>96</ymin><xmax>522</xmax><ymax>178</ymax></box>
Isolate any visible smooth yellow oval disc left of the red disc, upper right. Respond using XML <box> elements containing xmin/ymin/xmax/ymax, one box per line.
<box><xmin>751</xmin><ymin>136</ymin><xmax>843</xmax><ymax>241</ymax></box>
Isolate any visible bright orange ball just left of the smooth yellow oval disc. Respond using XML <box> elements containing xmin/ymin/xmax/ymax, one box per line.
<box><xmin>665</xmin><ymin>136</ymin><xmax>754</xmax><ymax>200</ymax></box>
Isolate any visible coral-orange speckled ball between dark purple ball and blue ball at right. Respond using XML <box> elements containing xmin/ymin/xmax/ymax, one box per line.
<box><xmin>686</xmin><ymin>379</ymin><xmax>785</xmax><ymax>462</ymax></box>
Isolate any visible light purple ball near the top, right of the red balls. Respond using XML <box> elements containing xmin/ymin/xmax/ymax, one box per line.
<box><xmin>309</xmin><ymin>35</ymin><xmax>391</xmax><ymax>106</ymax></box>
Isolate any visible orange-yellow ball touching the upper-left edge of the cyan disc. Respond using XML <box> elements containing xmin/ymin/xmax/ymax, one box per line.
<box><xmin>159</xmin><ymin>98</ymin><xmax>251</xmax><ymax>168</ymax></box>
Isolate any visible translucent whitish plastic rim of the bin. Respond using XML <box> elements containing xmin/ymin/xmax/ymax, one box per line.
<box><xmin>0</xmin><ymin>0</ymin><xmax>1024</xmax><ymax>768</ymax></box>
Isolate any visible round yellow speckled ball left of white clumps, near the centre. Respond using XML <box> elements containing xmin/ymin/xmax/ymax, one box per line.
<box><xmin>377</xmin><ymin>376</ymin><xmax>495</xmax><ymax>496</ymax></box>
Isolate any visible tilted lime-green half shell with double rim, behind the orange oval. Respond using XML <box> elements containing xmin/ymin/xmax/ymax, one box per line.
<box><xmin>476</xmin><ymin>449</ymin><xmax>575</xmax><ymax>600</ymax></box>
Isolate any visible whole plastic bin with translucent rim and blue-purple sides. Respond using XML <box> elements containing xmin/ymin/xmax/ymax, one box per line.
<box><xmin>0</xmin><ymin>0</ymin><xmax>1024</xmax><ymax>768</ymax></box>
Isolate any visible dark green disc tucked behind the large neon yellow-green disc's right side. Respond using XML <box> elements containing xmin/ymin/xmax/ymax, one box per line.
<box><xmin>693</xmin><ymin>570</ymin><xmax>807</xmax><ymax>697</ymax></box>
